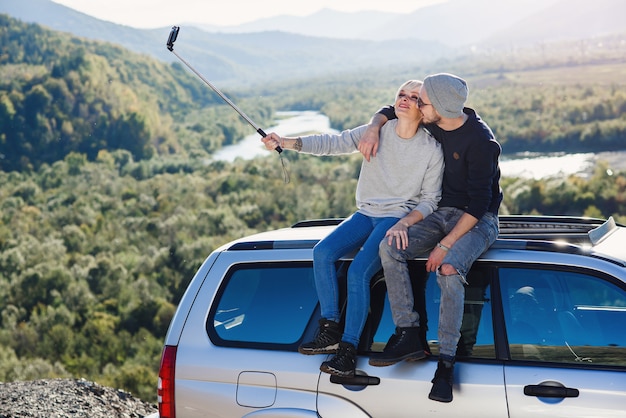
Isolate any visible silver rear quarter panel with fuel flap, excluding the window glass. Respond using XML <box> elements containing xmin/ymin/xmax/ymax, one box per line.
<box><xmin>175</xmin><ymin>249</ymin><xmax>319</xmax><ymax>418</ymax></box>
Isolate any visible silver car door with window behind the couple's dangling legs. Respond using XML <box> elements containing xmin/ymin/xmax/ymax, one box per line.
<box><xmin>317</xmin><ymin>262</ymin><xmax>507</xmax><ymax>418</ymax></box>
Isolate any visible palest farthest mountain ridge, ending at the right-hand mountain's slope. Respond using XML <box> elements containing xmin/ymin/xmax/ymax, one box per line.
<box><xmin>197</xmin><ymin>0</ymin><xmax>557</xmax><ymax>47</ymax></box>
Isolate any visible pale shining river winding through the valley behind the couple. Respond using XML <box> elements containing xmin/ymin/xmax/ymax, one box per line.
<box><xmin>213</xmin><ymin>111</ymin><xmax>626</xmax><ymax>179</ymax></box>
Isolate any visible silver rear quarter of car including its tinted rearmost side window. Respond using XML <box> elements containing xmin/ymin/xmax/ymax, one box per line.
<box><xmin>175</xmin><ymin>255</ymin><xmax>319</xmax><ymax>418</ymax></box>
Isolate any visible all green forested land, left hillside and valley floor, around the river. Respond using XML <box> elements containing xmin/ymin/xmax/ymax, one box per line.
<box><xmin>0</xmin><ymin>16</ymin><xmax>626</xmax><ymax>401</ymax></box>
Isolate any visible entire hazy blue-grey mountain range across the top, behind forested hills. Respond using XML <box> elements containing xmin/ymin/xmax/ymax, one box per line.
<box><xmin>0</xmin><ymin>0</ymin><xmax>626</xmax><ymax>86</ymax></box>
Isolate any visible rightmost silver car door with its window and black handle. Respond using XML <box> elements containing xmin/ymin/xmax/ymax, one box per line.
<box><xmin>499</xmin><ymin>265</ymin><xmax>626</xmax><ymax>418</ymax></box>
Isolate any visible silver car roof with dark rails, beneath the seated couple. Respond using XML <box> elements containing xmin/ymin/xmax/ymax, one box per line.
<box><xmin>221</xmin><ymin>215</ymin><xmax>626</xmax><ymax>267</ymax></box>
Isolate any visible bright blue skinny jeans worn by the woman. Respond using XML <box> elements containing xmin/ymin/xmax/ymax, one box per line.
<box><xmin>313</xmin><ymin>212</ymin><xmax>399</xmax><ymax>347</ymax></box>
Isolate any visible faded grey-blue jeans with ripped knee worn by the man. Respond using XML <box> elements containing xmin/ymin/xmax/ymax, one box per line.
<box><xmin>380</xmin><ymin>207</ymin><xmax>499</xmax><ymax>357</ymax></box>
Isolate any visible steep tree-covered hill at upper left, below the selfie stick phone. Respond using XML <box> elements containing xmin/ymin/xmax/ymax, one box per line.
<box><xmin>0</xmin><ymin>15</ymin><xmax>270</xmax><ymax>171</ymax></box>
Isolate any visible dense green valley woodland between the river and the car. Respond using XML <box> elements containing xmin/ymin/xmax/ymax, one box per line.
<box><xmin>0</xmin><ymin>138</ymin><xmax>626</xmax><ymax>401</ymax></box>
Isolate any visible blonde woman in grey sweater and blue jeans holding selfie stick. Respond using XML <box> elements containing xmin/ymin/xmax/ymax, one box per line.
<box><xmin>262</xmin><ymin>80</ymin><xmax>444</xmax><ymax>376</ymax></box>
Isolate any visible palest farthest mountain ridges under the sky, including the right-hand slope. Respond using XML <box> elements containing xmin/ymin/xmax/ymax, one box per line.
<box><xmin>150</xmin><ymin>0</ymin><xmax>626</xmax><ymax>48</ymax></box>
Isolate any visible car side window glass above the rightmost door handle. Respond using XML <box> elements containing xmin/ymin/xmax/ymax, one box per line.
<box><xmin>500</xmin><ymin>268</ymin><xmax>626</xmax><ymax>366</ymax></box>
